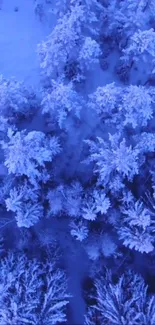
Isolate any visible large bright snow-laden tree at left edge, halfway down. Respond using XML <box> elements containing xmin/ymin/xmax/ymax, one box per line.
<box><xmin>1</xmin><ymin>129</ymin><xmax>60</xmax><ymax>183</ymax></box>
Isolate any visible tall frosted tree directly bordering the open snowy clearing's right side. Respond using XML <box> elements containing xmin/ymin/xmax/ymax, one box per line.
<box><xmin>38</xmin><ymin>4</ymin><xmax>86</xmax><ymax>77</ymax></box>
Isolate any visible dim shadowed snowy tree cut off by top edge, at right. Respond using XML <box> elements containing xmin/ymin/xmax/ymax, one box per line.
<box><xmin>102</xmin><ymin>0</ymin><xmax>150</xmax><ymax>48</ymax></box>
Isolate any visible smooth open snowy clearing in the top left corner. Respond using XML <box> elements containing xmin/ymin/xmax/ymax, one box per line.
<box><xmin>0</xmin><ymin>0</ymin><xmax>55</xmax><ymax>86</ymax></box>
